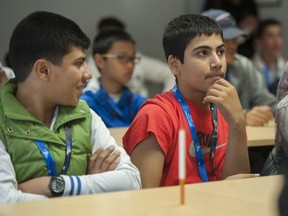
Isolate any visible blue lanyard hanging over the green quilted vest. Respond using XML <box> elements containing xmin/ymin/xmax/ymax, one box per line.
<box><xmin>35</xmin><ymin>124</ymin><xmax>72</xmax><ymax>176</ymax></box>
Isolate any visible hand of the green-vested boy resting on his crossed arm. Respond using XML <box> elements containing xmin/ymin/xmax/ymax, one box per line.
<box><xmin>87</xmin><ymin>146</ymin><xmax>121</xmax><ymax>174</ymax></box>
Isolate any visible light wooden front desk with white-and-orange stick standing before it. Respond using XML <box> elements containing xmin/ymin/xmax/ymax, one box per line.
<box><xmin>0</xmin><ymin>176</ymin><xmax>283</xmax><ymax>216</ymax></box>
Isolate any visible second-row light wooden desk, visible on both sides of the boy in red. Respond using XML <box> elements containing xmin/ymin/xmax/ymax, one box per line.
<box><xmin>109</xmin><ymin>124</ymin><xmax>275</xmax><ymax>147</ymax></box>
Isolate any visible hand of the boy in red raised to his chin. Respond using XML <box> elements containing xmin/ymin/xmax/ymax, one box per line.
<box><xmin>203</xmin><ymin>78</ymin><xmax>244</xmax><ymax>123</ymax></box>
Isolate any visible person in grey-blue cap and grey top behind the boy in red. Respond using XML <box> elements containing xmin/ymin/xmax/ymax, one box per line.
<box><xmin>202</xmin><ymin>9</ymin><xmax>277</xmax><ymax>126</ymax></box>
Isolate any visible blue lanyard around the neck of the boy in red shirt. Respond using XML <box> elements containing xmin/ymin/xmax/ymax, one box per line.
<box><xmin>172</xmin><ymin>85</ymin><xmax>218</xmax><ymax>182</ymax></box>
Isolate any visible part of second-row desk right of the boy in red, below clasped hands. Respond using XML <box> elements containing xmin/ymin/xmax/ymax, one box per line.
<box><xmin>246</xmin><ymin>123</ymin><xmax>276</xmax><ymax>147</ymax></box>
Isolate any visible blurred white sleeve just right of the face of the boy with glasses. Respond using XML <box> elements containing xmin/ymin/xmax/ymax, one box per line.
<box><xmin>139</xmin><ymin>54</ymin><xmax>175</xmax><ymax>92</ymax></box>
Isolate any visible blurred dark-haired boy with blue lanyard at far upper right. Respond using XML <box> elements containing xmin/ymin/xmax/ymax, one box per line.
<box><xmin>253</xmin><ymin>19</ymin><xmax>286</xmax><ymax>95</ymax></box>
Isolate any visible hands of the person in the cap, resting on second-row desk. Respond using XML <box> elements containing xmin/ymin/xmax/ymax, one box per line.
<box><xmin>245</xmin><ymin>106</ymin><xmax>274</xmax><ymax>126</ymax></box>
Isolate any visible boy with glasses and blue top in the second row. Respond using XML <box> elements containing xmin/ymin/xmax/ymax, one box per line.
<box><xmin>81</xmin><ymin>30</ymin><xmax>146</xmax><ymax>127</ymax></box>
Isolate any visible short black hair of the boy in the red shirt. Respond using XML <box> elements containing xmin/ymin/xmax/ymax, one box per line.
<box><xmin>162</xmin><ymin>14</ymin><xmax>223</xmax><ymax>63</ymax></box>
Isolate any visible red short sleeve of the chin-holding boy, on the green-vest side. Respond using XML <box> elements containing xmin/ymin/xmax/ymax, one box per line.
<box><xmin>123</xmin><ymin>104</ymin><xmax>175</xmax><ymax>156</ymax></box>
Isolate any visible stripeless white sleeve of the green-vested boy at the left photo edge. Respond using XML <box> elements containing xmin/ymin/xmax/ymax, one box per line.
<box><xmin>0</xmin><ymin>140</ymin><xmax>48</xmax><ymax>203</ymax></box>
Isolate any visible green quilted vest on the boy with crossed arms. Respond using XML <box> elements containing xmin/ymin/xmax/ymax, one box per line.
<box><xmin>0</xmin><ymin>80</ymin><xmax>92</xmax><ymax>184</ymax></box>
